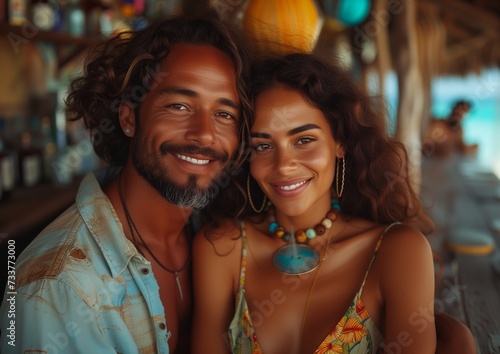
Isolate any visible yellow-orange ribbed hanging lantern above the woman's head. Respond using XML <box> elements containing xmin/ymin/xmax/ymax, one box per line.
<box><xmin>243</xmin><ymin>0</ymin><xmax>323</xmax><ymax>54</ymax></box>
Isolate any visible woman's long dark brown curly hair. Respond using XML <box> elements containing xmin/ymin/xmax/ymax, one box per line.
<box><xmin>205</xmin><ymin>54</ymin><xmax>432</xmax><ymax>232</ymax></box>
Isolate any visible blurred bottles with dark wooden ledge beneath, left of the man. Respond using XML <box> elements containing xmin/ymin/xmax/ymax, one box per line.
<box><xmin>0</xmin><ymin>106</ymin><xmax>102</xmax><ymax>244</ymax></box>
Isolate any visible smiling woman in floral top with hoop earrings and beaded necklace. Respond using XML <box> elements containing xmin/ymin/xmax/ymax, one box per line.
<box><xmin>193</xmin><ymin>54</ymin><xmax>436</xmax><ymax>354</ymax></box>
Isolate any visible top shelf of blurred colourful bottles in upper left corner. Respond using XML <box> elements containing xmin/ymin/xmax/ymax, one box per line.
<box><xmin>0</xmin><ymin>0</ymin><xmax>174</xmax><ymax>45</ymax></box>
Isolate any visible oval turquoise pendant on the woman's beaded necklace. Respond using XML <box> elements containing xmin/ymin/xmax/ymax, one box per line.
<box><xmin>273</xmin><ymin>244</ymin><xmax>319</xmax><ymax>275</ymax></box>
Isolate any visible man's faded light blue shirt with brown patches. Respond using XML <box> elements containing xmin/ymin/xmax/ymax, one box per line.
<box><xmin>0</xmin><ymin>170</ymin><xmax>170</xmax><ymax>354</ymax></box>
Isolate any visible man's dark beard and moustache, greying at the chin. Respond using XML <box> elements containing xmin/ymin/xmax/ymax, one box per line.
<box><xmin>130</xmin><ymin>136</ymin><xmax>229</xmax><ymax>209</ymax></box>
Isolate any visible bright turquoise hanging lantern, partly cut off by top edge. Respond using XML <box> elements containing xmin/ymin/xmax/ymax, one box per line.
<box><xmin>324</xmin><ymin>0</ymin><xmax>370</xmax><ymax>26</ymax></box>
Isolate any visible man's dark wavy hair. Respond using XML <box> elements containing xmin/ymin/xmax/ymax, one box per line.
<box><xmin>66</xmin><ymin>16</ymin><xmax>252</xmax><ymax>169</ymax></box>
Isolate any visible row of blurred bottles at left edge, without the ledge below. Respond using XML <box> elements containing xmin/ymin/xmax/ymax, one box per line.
<box><xmin>0</xmin><ymin>93</ymin><xmax>101</xmax><ymax>203</ymax></box>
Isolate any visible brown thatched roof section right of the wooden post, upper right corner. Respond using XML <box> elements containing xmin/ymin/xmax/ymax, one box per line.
<box><xmin>417</xmin><ymin>0</ymin><xmax>500</xmax><ymax>75</ymax></box>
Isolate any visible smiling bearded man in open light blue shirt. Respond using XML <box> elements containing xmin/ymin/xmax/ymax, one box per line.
<box><xmin>0</xmin><ymin>14</ymin><xmax>250</xmax><ymax>353</ymax></box>
